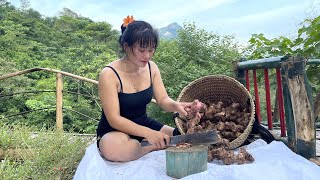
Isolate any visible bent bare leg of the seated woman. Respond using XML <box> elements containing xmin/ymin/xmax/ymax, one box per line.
<box><xmin>99</xmin><ymin>131</ymin><xmax>157</xmax><ymax>162</ymax></box>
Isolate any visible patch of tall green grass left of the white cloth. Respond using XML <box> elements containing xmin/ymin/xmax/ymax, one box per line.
<box><xmin>0</xmin><ymin>124</ymin><xmax>90</xmax><ymax>180</ymax></box>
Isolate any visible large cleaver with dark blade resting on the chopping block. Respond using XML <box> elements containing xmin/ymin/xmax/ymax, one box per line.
<box><xmin>141</xmin><ymin>130</ymin><xmax>218</xmax><ymax>146</ymax></box>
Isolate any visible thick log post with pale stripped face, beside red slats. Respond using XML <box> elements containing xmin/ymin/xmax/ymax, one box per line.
<box><xmin>281</xmin><ymin>56</ymin><xmax>316</xmax><ymax>159</ymax></box>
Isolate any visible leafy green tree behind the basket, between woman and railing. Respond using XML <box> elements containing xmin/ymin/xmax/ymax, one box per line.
<box><xmin>149</xmin><ymin>23</ymin><xmax>240</xmax><ymax>125</ymax></box>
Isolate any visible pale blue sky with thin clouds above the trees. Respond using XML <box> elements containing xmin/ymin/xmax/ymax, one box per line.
<box><xmin>8</xmin><ymin>0</ymin><xmax>320</xmax><ymax>43</ymax></box>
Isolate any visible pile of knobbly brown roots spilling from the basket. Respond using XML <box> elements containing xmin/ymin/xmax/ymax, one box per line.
<box><xmin>180</xmin><ymin>100</ymin><xmax>254</xmax><ymax>165</ymax></box>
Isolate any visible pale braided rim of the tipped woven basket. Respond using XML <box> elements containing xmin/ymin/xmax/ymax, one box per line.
<box><xmin>174</xmin><ymin>75</ymin><xmax>255</xmax><ymax>149</ymax></box>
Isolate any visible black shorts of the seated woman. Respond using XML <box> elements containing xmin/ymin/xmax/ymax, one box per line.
<box><xmin>97</xmin><ymin>117</ymin><xmax>164</xmax><ymax>148</ymax></box>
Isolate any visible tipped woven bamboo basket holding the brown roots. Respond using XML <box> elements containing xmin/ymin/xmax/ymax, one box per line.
<box><xmin>174</xmin><ymin>75</ymin><xmax>255</xmax><ymax>149</ymax></box>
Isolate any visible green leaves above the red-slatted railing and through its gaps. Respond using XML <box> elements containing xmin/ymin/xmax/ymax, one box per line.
<box><xmin>245</xmin><ymin>16</ymin><xmax>320</xmax><ymax>124</ymax></box>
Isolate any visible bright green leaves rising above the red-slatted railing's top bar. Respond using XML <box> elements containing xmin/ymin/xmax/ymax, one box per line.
<box><xmin>247</xmin><ymin>16</ymin><xmax>320</xmax><ymax>59</ymax></box>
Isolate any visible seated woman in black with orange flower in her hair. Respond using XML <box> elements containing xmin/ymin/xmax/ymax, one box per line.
<box><xmin>97</xmin><ymin>16</ymin><xmax>191</xmax><ymax>161</ymax></box>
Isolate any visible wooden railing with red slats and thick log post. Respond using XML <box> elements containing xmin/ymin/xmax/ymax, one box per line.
<box><xmin>235</xmin><ymin>56</ymin><xmax>320</xmax><ymax>159</ymax></box>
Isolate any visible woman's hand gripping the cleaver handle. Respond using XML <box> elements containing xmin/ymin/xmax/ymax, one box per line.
<box><xmin>145</xmin><ymin>129</ymin><xmax>170</xmax><ymax>149</ymax></box>
